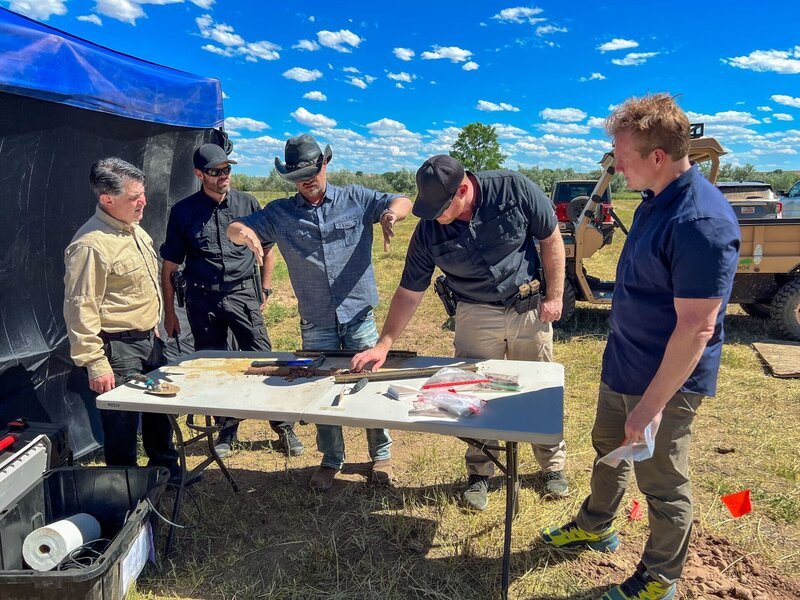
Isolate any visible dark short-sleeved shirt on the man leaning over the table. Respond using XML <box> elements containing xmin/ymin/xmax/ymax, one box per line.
<box><xmin>400</xmin><ymin>171</ymin><xmax>558</xmax><ymax>303</ymax></box>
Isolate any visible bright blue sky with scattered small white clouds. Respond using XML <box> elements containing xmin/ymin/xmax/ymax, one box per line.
<box><xmin>6</xmin><ymin>0</ymin><xmax>800</xmax><ymax>175</ymax></box>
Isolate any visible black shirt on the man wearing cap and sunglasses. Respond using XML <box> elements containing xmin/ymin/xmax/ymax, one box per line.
<box><xmin>160</xmin><ymin>189</ymin><xmax>268</xmax><ymax>284</ymax></box>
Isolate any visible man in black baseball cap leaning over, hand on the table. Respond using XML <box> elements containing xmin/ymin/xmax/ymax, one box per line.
<box><xmin>352</xmin><ymin>155</ymin><xmax>569</xmax><ymax>510</ymax></box>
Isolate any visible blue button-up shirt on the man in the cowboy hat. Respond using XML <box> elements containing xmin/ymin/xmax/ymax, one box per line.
<box><xmin>236</xmin><ymin>184</ymin><xmax>400</xmax><ymax>325</ymax></box>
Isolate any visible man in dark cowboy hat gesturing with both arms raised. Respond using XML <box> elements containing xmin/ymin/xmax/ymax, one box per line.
<box><xmin>227</xmin><ymin>134</ymin><xmax>411</xmax><ymax>491</ymax></box>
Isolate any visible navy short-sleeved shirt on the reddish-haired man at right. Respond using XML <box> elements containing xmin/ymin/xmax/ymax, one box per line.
<box><xmin>601</xmin><ymin>167</ymin><xmax>739</xmax><ymax>396</ymax></box>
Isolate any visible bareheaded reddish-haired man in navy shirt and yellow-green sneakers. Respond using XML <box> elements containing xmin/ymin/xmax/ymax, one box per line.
<box><xmin>542</xmin><ymin>94</ymin><xmax>739</xmax><ymax>600</ymax></box>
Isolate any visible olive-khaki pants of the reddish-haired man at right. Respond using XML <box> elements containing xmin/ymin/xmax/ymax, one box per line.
<box><xmin>575</xmin><ymin>383</ymin><xmax>704</xmax><ymax>583</ymax></box>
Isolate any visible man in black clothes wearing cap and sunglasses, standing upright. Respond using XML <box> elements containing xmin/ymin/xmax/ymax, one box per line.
<box><xmin>161</xmin><ymin>144</ymin><xmax>303</xmax><ymax>456</ymax></box>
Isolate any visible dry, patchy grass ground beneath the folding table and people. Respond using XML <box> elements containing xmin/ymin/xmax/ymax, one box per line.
<box><xmin>131</xmin><ymin>198</ymin><xmax>800</xmax><ymax>600</ymax></box>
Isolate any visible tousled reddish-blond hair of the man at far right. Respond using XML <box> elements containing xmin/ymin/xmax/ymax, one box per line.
<box><xmin>606</xmin><ymin>93</ymin><xmax>689</xmax><ymax>160</ymax></box>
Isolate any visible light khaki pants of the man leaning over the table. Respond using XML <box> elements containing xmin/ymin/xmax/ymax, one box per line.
<box><xmin>453</xmin><ymin>302</ymin><xmax>567</xmax><ymax>477</ymax></box>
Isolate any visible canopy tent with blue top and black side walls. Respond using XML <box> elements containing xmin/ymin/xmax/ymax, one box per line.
<box><xmin>0</xmin><ymin>9</ymin><xmax>223</xmax><ymax>456</ymax></box>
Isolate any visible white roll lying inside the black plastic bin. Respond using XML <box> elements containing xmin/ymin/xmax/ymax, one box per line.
<box><xmin>22</xmin><ymin>513</ymin><xmax>100</xmax><ymax>571</ymax></box>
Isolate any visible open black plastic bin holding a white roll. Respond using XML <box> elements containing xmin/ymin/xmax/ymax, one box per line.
<box><xmin>0</xmin><ymin>467</ymin><xmax>169</xmax><ymax>600</ymax></box>
